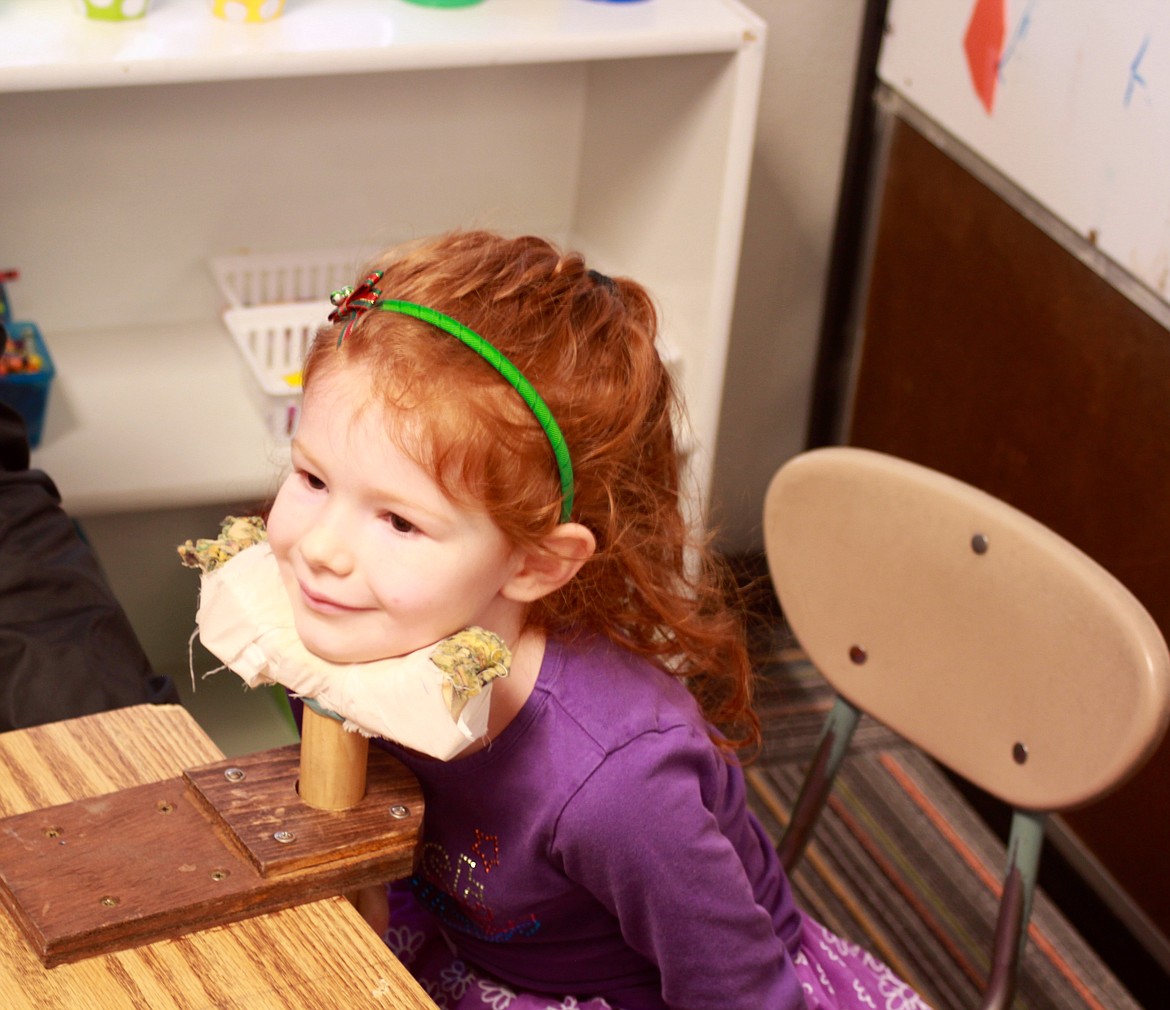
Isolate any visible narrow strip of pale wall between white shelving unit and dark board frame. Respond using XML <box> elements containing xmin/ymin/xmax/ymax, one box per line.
<box><xmin>713</xmin><ymin>0</ymin><xmax>865</xmax><ymax>552</ymax></box>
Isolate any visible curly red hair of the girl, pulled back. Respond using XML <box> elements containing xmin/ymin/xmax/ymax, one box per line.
<box><xmin>304</xmin><ymin>231</ymin><xmax>759</xmax><ymax>748</ymax></box>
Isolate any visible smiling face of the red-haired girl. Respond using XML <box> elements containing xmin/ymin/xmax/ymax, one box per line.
<box><xmin>268</xmin><ymin>366</ymin><xmax>523</xmax><ymax>662</ymax></box>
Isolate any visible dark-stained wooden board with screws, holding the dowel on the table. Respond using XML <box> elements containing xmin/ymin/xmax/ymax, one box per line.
<box><xmin>0</xmin><ymin>744</ymin><xmax>422</xmax><ymax>967</ymax></box>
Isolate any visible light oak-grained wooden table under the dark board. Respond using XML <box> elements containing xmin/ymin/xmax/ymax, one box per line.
<box><xmin>0</xmin><ymin>706</ymin><xmax>435</xmax><ymax>1010</ymax></box>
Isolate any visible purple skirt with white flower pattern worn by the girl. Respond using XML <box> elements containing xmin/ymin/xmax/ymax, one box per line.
<box><xmin>383</xmin><ymin>889</ymin><xmax>930</xmax><ymax>1010</ymax></box>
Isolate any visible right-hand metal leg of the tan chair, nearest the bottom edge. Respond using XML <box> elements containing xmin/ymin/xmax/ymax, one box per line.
<box><xmin>979</xmin><ymin>810</ymin><xmax>1047</xmax><ymax>1010</ymax></box>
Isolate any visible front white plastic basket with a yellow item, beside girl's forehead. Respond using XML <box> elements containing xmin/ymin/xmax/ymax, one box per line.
<box><xmin>223</xmin><ymin>302</ymin><xmax>332</xmax><ymax>439</ymax></box>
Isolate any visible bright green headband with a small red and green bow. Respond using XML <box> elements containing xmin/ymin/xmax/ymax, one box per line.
<box><xmin>329</xmin><ymin>270</ymin><xmax>573</xmax><ymax>522</ymax></box>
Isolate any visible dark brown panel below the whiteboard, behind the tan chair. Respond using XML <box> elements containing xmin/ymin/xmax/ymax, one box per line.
<box><xmin>848</xmin><ymin>122</ymin><xmax>1170</xmax><ymax>935</ymax></box>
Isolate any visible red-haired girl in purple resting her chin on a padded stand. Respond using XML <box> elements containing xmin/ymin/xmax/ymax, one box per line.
<box><xmin>260</xmin><ymin>232</ymin><xmax>922</xmax><ymax>1010</ymax></box>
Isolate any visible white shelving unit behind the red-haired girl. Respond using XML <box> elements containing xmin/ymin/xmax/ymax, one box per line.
<box><xmin>0</xmin><ymin>0</ymin><xmax>764</xmax><ymax>515</ymax></box>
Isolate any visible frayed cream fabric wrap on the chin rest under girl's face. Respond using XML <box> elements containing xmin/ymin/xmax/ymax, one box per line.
<box><xmin>195</xmin><ymin>543</ymin><xmax>491</xmax><ymax>761</ymax></box>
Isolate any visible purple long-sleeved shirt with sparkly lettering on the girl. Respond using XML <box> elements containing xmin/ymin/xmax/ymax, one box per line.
<box><xmin>381</xmin><ymin>640</ymin><xmax>804</xmax><ymax>1010</ymax></box>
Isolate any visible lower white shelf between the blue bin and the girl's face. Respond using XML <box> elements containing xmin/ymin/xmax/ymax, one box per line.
<box><xmin>33</xmin><ymin>322</ymin><xmax>288</xmax><ymax>516</ymax></box>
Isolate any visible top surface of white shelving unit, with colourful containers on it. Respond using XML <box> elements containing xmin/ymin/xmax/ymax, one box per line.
<box><xmin>0</xmin><ymin>0</ymin><xmax>751</xmax><ymax>91</ymax></box>
